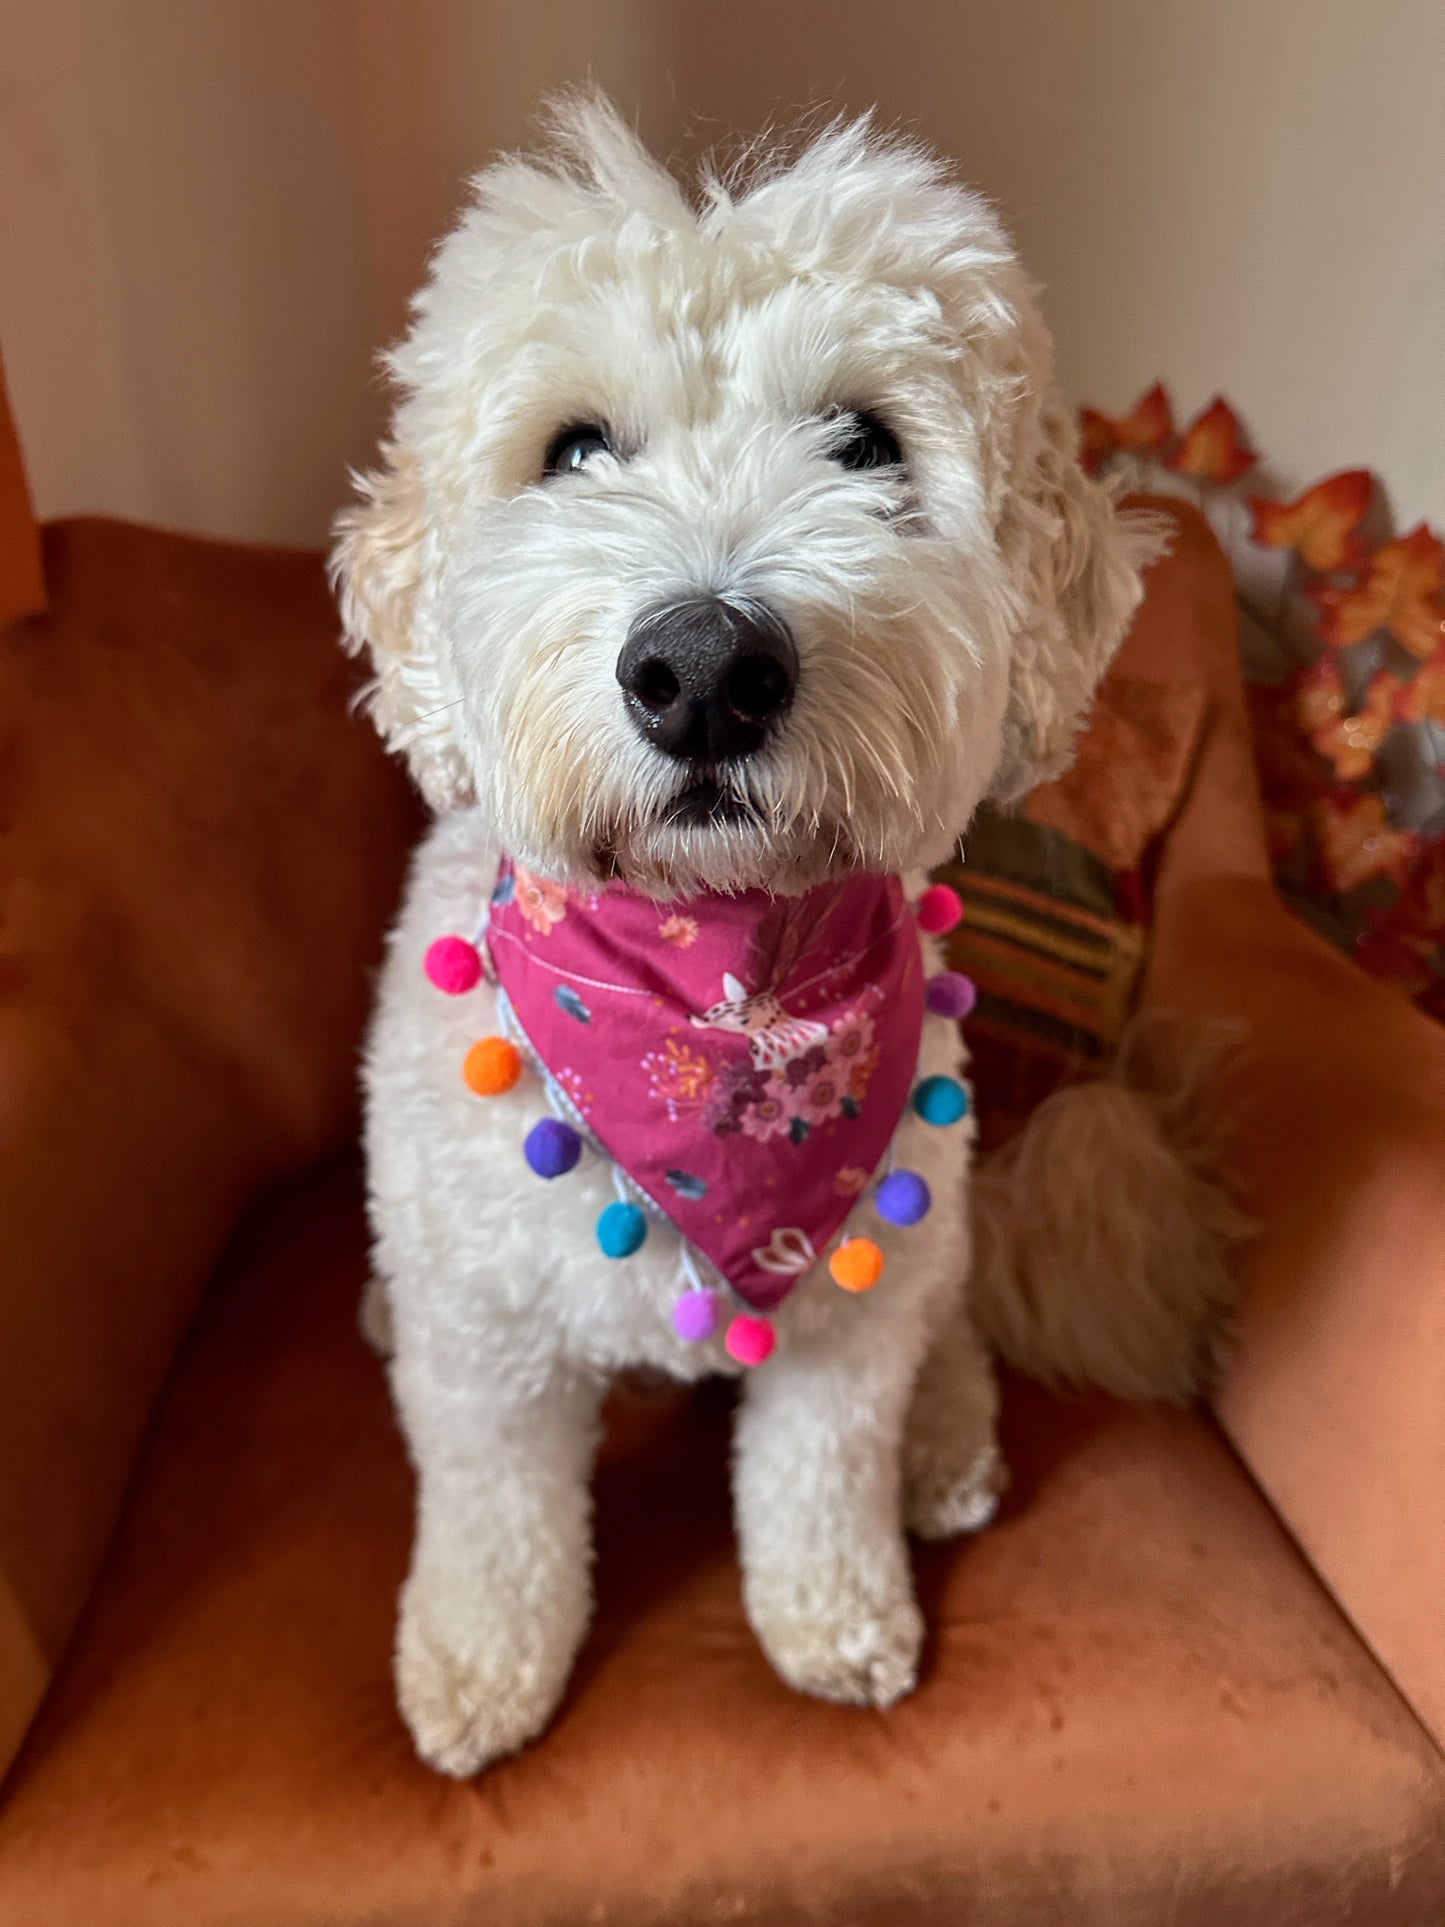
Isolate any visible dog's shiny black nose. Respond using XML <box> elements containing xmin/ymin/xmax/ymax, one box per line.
<box><xmin>617</xmin><ymin>595</ymin><xmax>798</xmax><ymax>763</ymax></box>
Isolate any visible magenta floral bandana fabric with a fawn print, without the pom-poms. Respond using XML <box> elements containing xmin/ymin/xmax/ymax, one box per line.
<box><xmin>487</xmin><ymin>861</ymin><xmax>923</xmax><ymax>1310</ymax></box>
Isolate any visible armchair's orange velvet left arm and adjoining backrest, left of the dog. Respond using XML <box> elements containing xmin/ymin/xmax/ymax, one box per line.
<box><xmin>0</xmin><ymin>520</ymin><xmax>412</xmax><ymax>1769</ymax></box>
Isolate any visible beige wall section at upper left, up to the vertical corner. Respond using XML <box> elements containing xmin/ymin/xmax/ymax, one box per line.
<box><xmin>0</xmin><ymin>0</ymin><xmax>376</xmax><ymax>541</ymax></box>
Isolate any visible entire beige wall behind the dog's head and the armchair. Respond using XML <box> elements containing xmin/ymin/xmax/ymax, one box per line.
<box><xmin>0</xmin><ymin>0</ymin><xmax>1445</xmax><ymax>540</ymax></box>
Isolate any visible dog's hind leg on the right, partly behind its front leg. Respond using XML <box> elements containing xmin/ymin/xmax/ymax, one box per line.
<box><xmin>904</xmin><ymin>1293</ymin><xmax>1006</xmax><ymax>1540</ymax></box>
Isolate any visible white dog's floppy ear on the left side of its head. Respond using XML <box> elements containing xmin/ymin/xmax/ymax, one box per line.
<box><xmin>329</xmin><ymin>443</ymin><xmax>468</xmax><ymax>811</ymax></box>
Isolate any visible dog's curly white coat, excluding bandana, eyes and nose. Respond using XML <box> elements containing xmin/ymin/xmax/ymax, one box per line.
<box><xmin>335</xmin><ymin>102</ymin><xmax>1150</xmax><ymax>1773</ymax></box>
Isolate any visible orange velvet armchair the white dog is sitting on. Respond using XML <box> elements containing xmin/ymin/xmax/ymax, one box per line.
<box><xmin>0</xmin><ymin>368</ymin><xmax>1445</xmax><ymax>1927</ymax></box>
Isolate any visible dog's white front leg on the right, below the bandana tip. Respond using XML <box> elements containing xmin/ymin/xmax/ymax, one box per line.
<box><xmin>734</xmin><ymin>1303</ymin><xmax>923</xmax><ymax>1705</ymax></box>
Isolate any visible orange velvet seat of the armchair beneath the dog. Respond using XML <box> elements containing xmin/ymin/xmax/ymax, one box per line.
<box><xmin>0</xmin><ymin>1166</ymin><xmax>1445</xmax><ymax>1927</ymax></box>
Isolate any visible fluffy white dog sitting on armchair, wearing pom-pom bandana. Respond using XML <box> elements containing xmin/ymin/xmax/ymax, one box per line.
<box><xmin>335</xmin><ymin>102</ymin><xmax>1225</xmax><ymax>1775</ymax></box>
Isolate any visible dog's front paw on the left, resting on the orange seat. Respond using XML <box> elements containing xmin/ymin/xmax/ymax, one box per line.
<box><xmin>397</xmin><ymin>1603</ymin><xmax>566</xmax><ymax>1781</ymax></box>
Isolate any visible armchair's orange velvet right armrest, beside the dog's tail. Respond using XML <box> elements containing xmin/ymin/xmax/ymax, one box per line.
<box><xmin>1148</xmin><ymin>875</ymin><xmax>1445</xmax><ymax>1742</ymax></box>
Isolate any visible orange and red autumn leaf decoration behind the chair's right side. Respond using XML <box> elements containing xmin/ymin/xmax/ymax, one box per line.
<box><xmin>1079</xmin><ymin>382</ymin><xmax>1445</xmax><ymax>1019</ymax></box>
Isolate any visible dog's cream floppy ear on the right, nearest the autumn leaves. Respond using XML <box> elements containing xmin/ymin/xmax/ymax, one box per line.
<box><xmin>990</xmin><ymin>385</ymin><xmax>1166</xmax><ymax>804</ymax></box>
